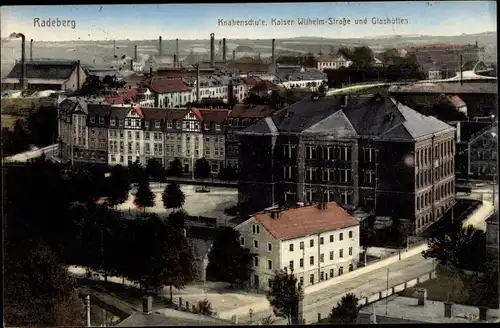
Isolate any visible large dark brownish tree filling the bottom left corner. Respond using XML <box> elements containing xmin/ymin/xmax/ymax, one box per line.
<box><xmin>4</xmin><ymin>241</ymin><xmax>85</xmax><ymax>327</ymax></box>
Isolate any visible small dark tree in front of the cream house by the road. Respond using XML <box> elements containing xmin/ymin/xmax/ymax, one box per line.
<box><xmin>266</xmin><ymin>270</ymin><xmax>304</xmax><ymax>325</ymax></box>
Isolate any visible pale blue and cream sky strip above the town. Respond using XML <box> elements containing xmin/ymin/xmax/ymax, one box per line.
<box><xmin>1</xmin><ymin>1</ymin><xmax>497</xmax><ymax>41</ymax></box>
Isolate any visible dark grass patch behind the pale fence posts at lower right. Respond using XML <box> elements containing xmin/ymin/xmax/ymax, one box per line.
<box><xmin>399</xmin><ymin>275</ymin><xmax>474</xmax><ymax>305</ymax></box>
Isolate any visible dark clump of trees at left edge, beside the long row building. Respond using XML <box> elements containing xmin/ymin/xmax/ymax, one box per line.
<box><xmin>2</xmin><ymin>106</ymin><xmax>57</xmax><ymax>157</ymax></box>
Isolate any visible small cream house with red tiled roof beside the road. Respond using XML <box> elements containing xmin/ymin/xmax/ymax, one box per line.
<box><xmin>235</xmin><ymin>202</ymin><xmax>359</xmax><ymax>289</ymax></box>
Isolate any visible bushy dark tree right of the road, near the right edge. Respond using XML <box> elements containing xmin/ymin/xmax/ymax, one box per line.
<box><xmin>422</xmin><ymin>221</ymin><xmax>486</xmax><ymax>270</ymax></box>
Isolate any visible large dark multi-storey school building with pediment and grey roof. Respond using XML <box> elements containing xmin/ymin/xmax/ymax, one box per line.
<box><xmin>237</xmin><ymin>94</ymin><xmax>455</xmax><ymax>233</ymax></box>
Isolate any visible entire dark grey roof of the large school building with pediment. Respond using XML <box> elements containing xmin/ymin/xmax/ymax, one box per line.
<box><xmin>239</xmin><ymin>94</ymin><xmax>452</xmax><ymax>140</ymax></box>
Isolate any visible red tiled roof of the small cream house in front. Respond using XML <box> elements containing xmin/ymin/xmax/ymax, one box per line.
<box><xmin>254</xmin><ymin>202</ymin><xmax>358</xmax><ymax>240</ymax></box>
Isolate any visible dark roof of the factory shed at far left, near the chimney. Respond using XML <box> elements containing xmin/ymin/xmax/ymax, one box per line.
<box><xmin>7</xmin><ymin>61</ymin><xmax>77</xmax><ymax>80</ymax></box>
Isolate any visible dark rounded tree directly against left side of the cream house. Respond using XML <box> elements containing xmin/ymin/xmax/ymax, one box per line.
<box><xmin>207</xmin><ymin>227</ymin><xmax>253</xmax><ymax>285</ymax></box>
